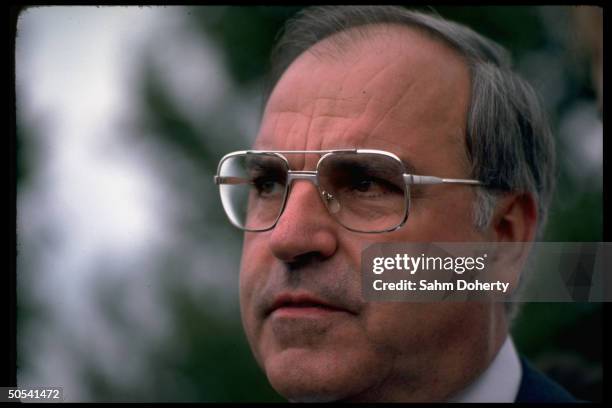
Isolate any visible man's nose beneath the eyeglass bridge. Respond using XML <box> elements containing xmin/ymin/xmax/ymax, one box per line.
<box><xmin>269</xmin><ymin>180</ymin><xmax>338</xmax><ymax>262</ymax></box>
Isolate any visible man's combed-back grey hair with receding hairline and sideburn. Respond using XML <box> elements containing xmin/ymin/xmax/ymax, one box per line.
<box><xmin>264</xmin><ymin>6</ymin><xmax>555</xmax><ymax>319</ymax></box>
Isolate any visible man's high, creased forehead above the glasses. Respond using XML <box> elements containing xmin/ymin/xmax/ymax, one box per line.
<box><xmin>255</xmin><ymin>25</ymin><xmax>470</xmax><ymax>171</ymax></box>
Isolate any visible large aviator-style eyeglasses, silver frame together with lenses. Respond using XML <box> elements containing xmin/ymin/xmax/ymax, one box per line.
<box><xmin>214</xmin><ymin>149</ymin><xmax>482</xmax><ymax>233</ymax></box>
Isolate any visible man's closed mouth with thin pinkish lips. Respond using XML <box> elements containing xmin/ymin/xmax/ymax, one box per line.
<box><xmin>266</xmin><ymin>294</ymin><xmax>350</xmax><ymax>318</ymax></box>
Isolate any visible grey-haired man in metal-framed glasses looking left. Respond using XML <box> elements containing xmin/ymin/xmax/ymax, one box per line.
<box><xmin>216</xmin><ymin>6</ymin><xmax>573</xmax><ymax>402</ymax></box>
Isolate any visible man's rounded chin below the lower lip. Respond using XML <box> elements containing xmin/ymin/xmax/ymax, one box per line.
<box><xmin>264</xmin><ymin>349</ymin><xmax>377</xmax><ymax>402</ymax></box>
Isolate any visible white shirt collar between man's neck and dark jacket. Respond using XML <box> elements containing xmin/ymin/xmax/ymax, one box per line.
<box><xmin>450</xmin><ymin>336</ymin><xmax>523</xmax><ymax>402</ymax></box>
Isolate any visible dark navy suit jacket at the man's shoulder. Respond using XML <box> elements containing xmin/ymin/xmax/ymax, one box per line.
<box><xmin>515</xmin><ymin>357</ymin><xmax>582</xmax><ymax>402</ymax></box>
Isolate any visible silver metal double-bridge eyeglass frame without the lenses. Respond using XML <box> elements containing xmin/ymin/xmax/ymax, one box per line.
<box><xmin>213</xmin><ymin>149</ymin><xmax>483</xmax><ymax>234</ymax></box>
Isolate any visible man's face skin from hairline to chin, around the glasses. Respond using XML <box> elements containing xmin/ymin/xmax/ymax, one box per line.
<box><xmin>240</xmin><ymin>27</ymin><xmax>500</xmax><ymax>400</ymax></box>
